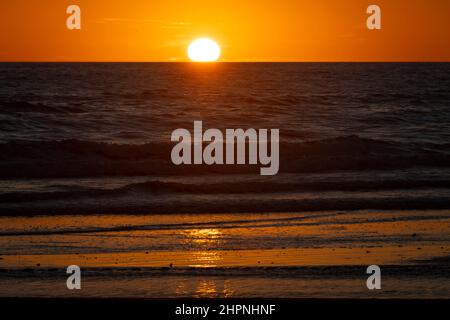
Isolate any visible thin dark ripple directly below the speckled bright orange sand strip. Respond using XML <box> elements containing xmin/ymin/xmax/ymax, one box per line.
<box><xmin>0</xmin><ymin>263</ymin><xmax>450</xmax><ymax>279</ymax></box>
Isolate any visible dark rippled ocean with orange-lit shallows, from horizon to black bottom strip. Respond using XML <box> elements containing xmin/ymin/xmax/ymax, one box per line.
<box><xmin>0</xmin><ymin>63</ymin><xmax>450</xmax><ymax>297</ymax></box>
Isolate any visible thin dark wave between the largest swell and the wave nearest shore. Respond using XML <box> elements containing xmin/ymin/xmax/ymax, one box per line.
<box><xmin>0</xmin><ymin>179</ymin><xmax>450</xmax><ymax>203</ymax></box>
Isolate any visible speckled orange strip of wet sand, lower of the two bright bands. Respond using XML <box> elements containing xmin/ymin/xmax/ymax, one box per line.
<box><xmin>0</xmin><ymin>244</ymin><xmax>450</xmax><ymax>269</ymax></box>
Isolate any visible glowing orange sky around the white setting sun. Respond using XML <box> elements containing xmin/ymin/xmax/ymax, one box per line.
<box><xmin>0</xmin><ymin>0</ymin><xmax>450</xmax><ymax>61</ymax></box>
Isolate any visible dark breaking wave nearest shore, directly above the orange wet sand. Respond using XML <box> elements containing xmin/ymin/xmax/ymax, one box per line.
<box><xmin>0</xmin><ymin>194</ymin><xmax>450</xmax><ymax>216</ymax></box>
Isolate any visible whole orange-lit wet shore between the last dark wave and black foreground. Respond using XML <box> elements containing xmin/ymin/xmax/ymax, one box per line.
<box><xmin>0</xmin><ymin>210</ymin><xmax>450</xmax><ymax>298</ymax></box>
